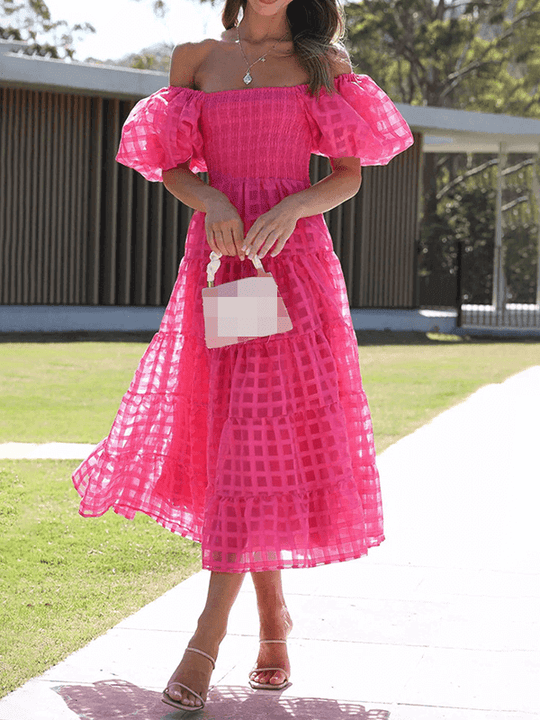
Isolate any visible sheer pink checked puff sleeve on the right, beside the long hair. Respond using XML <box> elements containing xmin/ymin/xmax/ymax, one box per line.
<box><xmin>304</xmin><ymin>73</ymin><xmax>414</xmax><ymax>165</ymax></box>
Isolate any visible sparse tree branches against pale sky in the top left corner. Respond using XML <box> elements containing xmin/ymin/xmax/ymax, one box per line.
<box><xmin>0</xmin><ymin>0</ymin><xmax>96</xmax><ymax>60</ymax></box>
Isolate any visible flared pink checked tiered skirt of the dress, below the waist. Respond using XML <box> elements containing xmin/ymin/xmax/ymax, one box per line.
<box><xmin>72</xmin><ymin>205</ymin><xmax>384</xmax><ymax>572</ymax></box>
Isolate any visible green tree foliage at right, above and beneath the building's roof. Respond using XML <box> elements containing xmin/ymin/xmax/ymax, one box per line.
<box><xmin>345</xmin><ymin>0</ymin><xmax>540</xmax><ymax>302</ymax></box>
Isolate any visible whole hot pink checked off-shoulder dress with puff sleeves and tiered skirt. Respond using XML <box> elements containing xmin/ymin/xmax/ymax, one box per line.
<box><xmin>73</xmin><ymin>73</ymin><xmax>413</xmax><ymax>572</ymax></box>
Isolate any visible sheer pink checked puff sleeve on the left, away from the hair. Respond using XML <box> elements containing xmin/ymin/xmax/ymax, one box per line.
<box><xmin>116</xmin><ymin>85</ymin><xmax>207</xmax><ymax>182</ymax></box>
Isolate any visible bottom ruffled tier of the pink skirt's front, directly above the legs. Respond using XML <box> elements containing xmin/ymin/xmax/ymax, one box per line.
<box><xmin>203</xmin><ymin>465</ymin><xmax>382</xmax><ymax>572</ymax></box>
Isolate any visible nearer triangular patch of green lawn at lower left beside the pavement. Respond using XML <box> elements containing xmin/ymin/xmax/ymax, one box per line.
<box><xmin>0</xmin><ymin>460</ymin><xmax>201</xmax><ymax>696</ymax></box>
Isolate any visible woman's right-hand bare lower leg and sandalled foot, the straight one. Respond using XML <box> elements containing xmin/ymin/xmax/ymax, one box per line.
<box><xmin>251</xmin><ymin>570</ymin><xmax>292</xmax><ymax>685</ymax></box>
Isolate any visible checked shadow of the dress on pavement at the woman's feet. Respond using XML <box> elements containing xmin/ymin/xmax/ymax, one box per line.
<box><xmin>53</xmin><ymin>680</ymin><xmax>390</xmax><ymax>720</ymax></box>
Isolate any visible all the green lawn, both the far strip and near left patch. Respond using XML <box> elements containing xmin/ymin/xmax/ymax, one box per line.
<box><xmin>0</xmin><ymin>333</ymin><xmax>540</xmax><ymax>696</ymax></box>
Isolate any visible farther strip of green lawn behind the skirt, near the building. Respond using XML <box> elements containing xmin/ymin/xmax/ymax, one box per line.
<box><xmin>0</xmin><ymin>333</ymin><xmax>540</xmax><ymax>452</ymax></box>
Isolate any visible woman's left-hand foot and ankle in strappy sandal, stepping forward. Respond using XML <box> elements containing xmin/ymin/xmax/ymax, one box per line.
<box><xmin>163</xmin><ymin>628</ymin><xmax>226</xmax><ymax>707</ymax></box>
